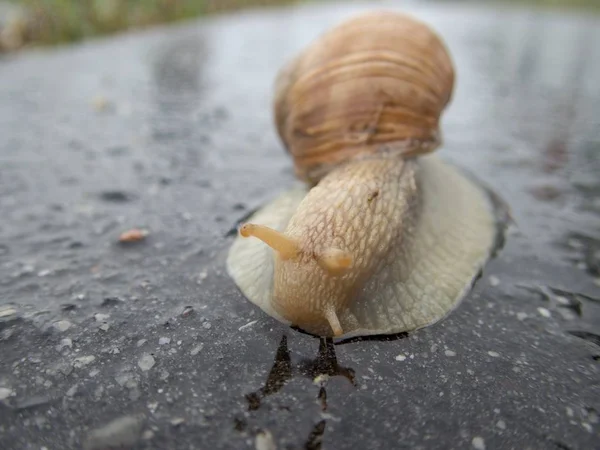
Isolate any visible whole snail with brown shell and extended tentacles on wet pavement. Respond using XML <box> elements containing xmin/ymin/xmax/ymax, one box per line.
<box><xmin>227</xmin><ymin>12</ymin><xmax>503</xmax><ymax>338</ymax></box>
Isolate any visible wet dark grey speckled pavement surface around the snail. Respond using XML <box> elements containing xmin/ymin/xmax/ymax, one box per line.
<box><xmin>0</xmin><ymin>4</ymin><xmax>600</xmax><ymax>449</ymax></box>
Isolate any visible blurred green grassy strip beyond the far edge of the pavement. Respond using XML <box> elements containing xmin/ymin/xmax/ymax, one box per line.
<box><xmin>0</xmin><ymin>0</ymin><xmax>600</xmax><ymax>52</ymax></box>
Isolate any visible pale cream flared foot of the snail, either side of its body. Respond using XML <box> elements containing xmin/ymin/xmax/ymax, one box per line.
<box><xmin>227</xmin><ymin>155</ymin><xmax>499</xmax><ymax>338</ymax></box>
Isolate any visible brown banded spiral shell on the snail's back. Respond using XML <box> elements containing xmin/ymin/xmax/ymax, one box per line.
<box><xmin>274</xmin><ymin>12</ymin><xmax>454</xmax><ymax>183</ymax></box>
